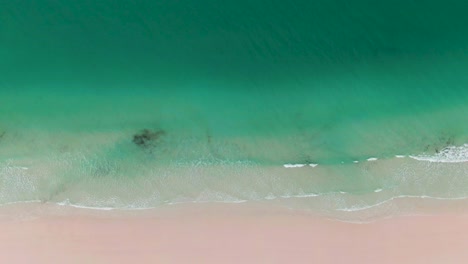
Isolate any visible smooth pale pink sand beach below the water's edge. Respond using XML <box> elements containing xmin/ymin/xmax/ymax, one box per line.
<box><xmin>0</xmin><ymin>204</ymin><xmax>468</xmax><ymax>263</ymax></box>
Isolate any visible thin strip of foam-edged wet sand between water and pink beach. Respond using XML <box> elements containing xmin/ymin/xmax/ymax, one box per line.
<box><xmin>0</xmin><ymin>192</ymin><xmax>468</xmax><ymax>224</ymax></box>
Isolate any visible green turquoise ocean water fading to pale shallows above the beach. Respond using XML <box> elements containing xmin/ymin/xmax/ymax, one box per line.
<box><xmin>0</xmin><ymin>0</ymin><xmax>468</xmax><ymax>219</ymax></box>
